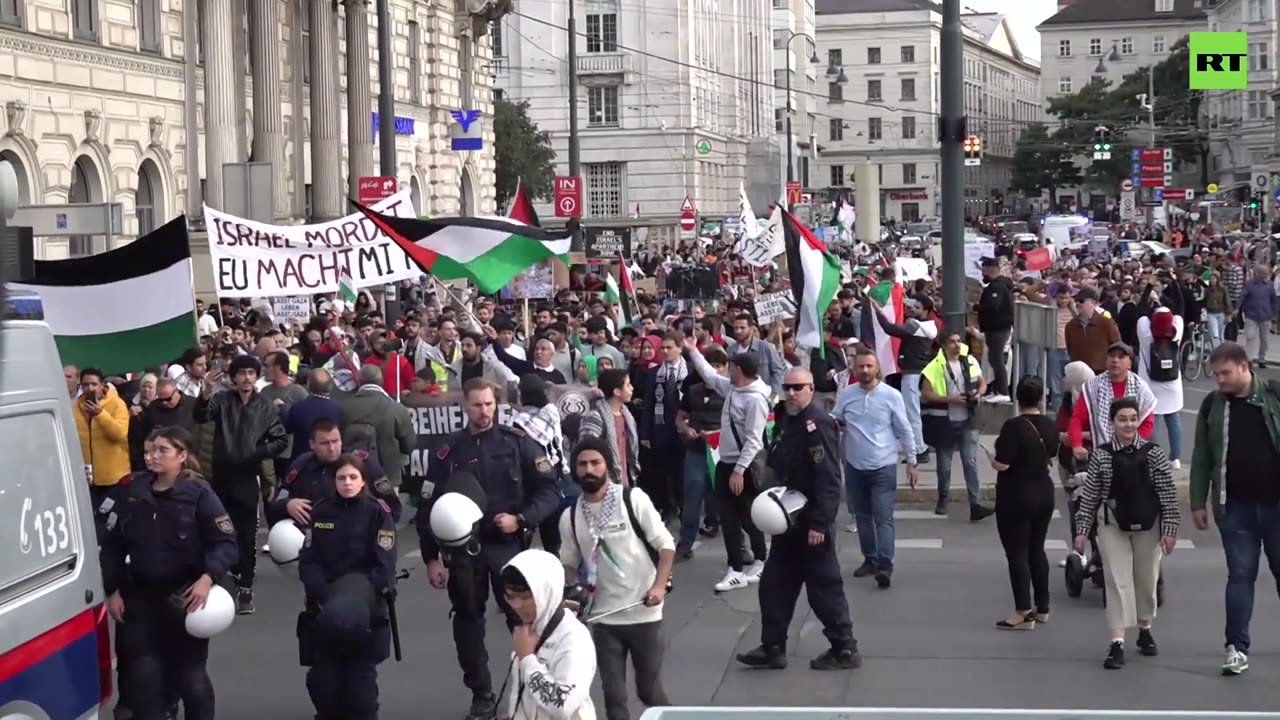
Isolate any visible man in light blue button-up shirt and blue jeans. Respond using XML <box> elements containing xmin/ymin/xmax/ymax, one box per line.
<box><xmin>833</xmin><ymin>346</ymin><xmax>924</xmax><ymax>588</ymax></box>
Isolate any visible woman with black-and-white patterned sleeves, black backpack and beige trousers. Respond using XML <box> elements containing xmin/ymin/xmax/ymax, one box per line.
<box><xmin>1074</xmin><ymin>396</ymin><xmax>1181</xmax><ymax>670</ymax></box>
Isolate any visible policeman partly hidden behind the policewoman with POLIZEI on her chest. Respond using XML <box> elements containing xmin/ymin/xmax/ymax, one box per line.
<box><xmin>266</xmin><ymin>418</ymin><xmax>401</xmax><ymax>527</ymax></box>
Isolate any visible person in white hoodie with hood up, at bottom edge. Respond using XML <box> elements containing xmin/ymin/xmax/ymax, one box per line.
<box><xmin>502</xmin><ymin>550</ymin><xmax>595</xmax><ymax>720</ymax></box>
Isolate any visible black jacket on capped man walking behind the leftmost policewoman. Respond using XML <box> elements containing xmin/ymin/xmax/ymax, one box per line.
<box><xmin>196</xmin><ymin>388</ymin><xmax>289</xmax><ymax>482</ymax></box>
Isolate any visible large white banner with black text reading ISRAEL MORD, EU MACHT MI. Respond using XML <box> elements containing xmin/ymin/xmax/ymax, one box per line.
<box><xmin>205</xmin><ymin>191</ymin><xmax>422</xmax><ymax>297</ymax></box>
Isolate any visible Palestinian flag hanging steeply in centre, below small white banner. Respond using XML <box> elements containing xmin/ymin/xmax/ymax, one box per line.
<box><xmin>778</xmin><ymin>208</ymin><xmax>840</xmax><ymax>348</ymax></box>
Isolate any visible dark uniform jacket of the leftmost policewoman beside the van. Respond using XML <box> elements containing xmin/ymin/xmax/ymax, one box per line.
<box><xmin>99</xmin><ymin>473</ymin><xmax>239</xmax><ymax>594</ymax></box>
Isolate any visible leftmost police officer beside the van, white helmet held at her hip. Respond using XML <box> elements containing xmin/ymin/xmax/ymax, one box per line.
<box><xmin>102</xmin><ymin>428</ymin><xmax>239</xmax><ymax>720</ymax></box>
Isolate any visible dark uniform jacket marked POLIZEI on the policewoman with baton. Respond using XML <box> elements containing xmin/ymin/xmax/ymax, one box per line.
<box><xmin>298</xmin><ymin>488</ymin><xmax>396</xmax><ymax>605</ymax></box>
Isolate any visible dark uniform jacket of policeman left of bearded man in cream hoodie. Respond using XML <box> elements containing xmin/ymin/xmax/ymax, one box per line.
<box><xmin>417</xmin><ymin>424</ymin><xmax>561</xmax><ymax>560</ymax></box>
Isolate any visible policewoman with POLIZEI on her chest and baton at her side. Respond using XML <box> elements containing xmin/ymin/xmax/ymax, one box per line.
<box><xmin>298</xmin><ymin>455</ymin><xmax>396</xmax><ymax>720</ymax></box>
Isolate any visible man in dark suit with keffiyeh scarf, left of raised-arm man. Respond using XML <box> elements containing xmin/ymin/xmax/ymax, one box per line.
<box><xmin>639</xmin><ymin>331</ymin><xmax>689</xmax><ymax>520</ymax></box>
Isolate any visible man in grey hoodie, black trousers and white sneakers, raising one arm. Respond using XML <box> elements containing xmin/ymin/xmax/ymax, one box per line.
<box><xmin>685</xmin><ymin>337</ymin><xmax>772</xmax><ymax>592</ymax></box>
